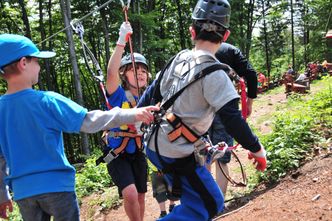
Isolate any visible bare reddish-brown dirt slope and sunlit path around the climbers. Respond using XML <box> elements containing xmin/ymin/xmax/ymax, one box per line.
<box><xmin>81</xmin><ymin>83</ymin><xmax>332</xmax><ymax>221</ymax></box>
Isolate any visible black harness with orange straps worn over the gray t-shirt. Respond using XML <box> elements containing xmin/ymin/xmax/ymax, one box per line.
<box><xmin>144</xmin><ymin>56</ymin><xmax>229</xmax><ymax>199</ymax></box>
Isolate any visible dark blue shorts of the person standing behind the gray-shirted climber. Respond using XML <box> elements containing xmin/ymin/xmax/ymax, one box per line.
<box><xmin>209</xmin><ymin>115</ymin><xmax>233</xmax><ymax>164</ymax></box>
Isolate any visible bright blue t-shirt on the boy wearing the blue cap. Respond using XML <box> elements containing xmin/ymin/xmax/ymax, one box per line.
<box><xmin>0</xmin><ymin>89</ymin><xmax>87</xmax><ymax>200</ymax></box>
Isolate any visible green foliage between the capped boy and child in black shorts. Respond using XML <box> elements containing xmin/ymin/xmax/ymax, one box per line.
<box><xmin>76</xmin><ymin>157</ymin><xmax>114</xmax><ymax>198</ymax></box>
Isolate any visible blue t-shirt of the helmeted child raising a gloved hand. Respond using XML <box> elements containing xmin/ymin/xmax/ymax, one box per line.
<box><xmin>108</xmin><ymin>86</ymin><xmax>137</xmax><ymax>153</ymax></box>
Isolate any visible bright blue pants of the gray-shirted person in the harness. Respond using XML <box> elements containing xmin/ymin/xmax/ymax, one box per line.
<box><xmin>146</xmin><ymin>148</ymin><xmax>224</xmax><ymax>221</ymax></box>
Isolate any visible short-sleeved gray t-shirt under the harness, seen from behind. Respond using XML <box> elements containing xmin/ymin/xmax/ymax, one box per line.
<box><xmin>148</xmin><ymin>50</ymin><xmax>239</xmax><ymax>158</ymax></box>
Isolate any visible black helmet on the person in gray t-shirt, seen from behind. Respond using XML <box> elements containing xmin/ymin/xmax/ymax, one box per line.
<box><xmin>192</xmin><ymin>0</ymin><xmax>231</xmax><ymax>29</ymax></box>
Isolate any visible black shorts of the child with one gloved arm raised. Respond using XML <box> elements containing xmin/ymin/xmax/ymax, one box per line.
<box><xmin>107</xmin><ymin>152</ymin><xmax>148</xmax><ymax>193</ymax></box>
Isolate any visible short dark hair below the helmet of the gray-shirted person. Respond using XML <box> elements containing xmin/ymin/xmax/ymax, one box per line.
<box><xmin>192</xmin><ymin>20</ymin><xmax>226</xmax><ymax>43</ymax></box>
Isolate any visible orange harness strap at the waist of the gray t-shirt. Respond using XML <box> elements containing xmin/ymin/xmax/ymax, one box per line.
<box><xmin>166</xmin><ymin>113</ymin><xmax>199</xmax><ymax>143</ymax></box>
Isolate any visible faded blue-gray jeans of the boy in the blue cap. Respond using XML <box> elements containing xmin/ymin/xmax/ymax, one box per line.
<box><xmin>16</xmin><ymin>192</ymin><xmax>80</xmax><ymax>221</ymax></box>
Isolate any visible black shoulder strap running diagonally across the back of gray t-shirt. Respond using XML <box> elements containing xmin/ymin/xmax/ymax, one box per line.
<box><xmin>160</xmin><ymin>63</ymin><xmax>230</xmax><ymax>113</ymax></box>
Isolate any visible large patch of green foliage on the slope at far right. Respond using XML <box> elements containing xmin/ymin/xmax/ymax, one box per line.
<box><xmin>261</xmin><ymin>78</ymin><xmax>332</xmax><ymax>182</ymax></box>
